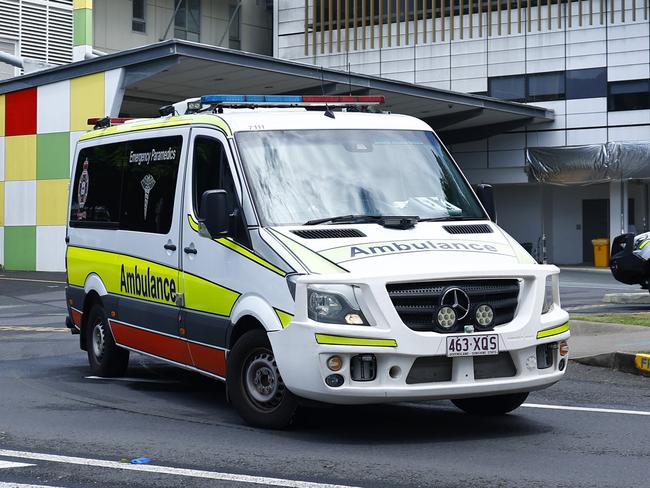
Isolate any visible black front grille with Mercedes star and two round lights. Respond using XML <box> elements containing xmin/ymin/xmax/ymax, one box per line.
<box><xmin>386</xmin><ymin>279</ymin><xmax>519</xmax><ymax>333</ymax></box>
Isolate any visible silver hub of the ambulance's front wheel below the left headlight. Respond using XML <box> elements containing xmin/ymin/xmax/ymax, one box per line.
<box><xmin>245</xmin><ymin>352</ymin><xmax>284</xmax><ymax>408</ymax></box>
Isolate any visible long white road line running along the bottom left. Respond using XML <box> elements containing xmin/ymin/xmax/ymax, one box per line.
<box><xmin>0</xmin><ymin>449</ymin><xmax>354</xmax><ymax>488</ymax></box>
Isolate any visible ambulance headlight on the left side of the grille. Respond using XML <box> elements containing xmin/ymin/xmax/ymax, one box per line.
<box><xmin>307</xmin><ymin>285</ymin><xmax>368</xmax><ymax>325</ymax></box>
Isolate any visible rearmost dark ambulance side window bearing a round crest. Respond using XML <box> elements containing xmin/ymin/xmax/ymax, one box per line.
<box><xmin>70</xmin><ymin>140</ymin><xmax>126</xmax><ymax>229</ymax></box>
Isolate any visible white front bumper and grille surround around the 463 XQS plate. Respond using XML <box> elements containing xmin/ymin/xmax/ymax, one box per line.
<box><xmin>269</xmin><ymin>267</ymin><xmax>569</xmax><ymax>404</ymax></box>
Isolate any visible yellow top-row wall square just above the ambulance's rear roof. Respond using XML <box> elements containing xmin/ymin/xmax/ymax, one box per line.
<box><xmin>70</xmin><ymin>73</ymin><xmax>106</xmax><ymax>131</ymax></box>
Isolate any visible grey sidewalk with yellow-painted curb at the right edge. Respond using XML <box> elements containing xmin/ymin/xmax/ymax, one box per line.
<box><xmin>569</xmin><ymin>320</ymin><xmax>650</xmax><ymax>375</ymax></box>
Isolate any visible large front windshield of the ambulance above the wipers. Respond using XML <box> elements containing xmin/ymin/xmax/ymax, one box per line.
<box><xmin>236</xmin><ymin>129</ymin><xmax>486</xmax><ymax>225</ymax></box>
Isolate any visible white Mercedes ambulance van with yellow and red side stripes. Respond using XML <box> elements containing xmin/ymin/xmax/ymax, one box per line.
<box><xmin>66</xmin><ymin>96</ymin><xmax>569</xmax><ymax>428</ymax></box>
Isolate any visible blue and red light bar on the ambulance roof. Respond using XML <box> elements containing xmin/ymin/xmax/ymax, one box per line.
<box><xmin>201</xmin><ymin>95</ymin><xmax>384</xmax><ymax>107</ymax></box>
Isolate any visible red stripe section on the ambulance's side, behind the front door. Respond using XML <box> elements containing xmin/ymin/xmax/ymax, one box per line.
<box><xmin>109</xmin><ymin>320</ymin><xmax>193</xmax><ymax>366</ymax></box>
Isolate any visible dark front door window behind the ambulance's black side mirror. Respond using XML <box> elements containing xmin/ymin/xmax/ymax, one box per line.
<box><xmin>192</xmin><ymin>136</ymin><xmax>248</xmax><ymax>244</ymax></box>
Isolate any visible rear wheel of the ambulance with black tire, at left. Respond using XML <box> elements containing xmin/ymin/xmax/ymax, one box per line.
<box><xmin>86</xmin><ymin>303</ymin><xmax>129</xmax><ymax>377</ymax></box>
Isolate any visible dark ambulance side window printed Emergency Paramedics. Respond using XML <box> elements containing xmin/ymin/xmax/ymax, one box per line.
<box><xmin>120</xmin><ymin>136</ymin><xmax>183</xmax><ymax>234</ymax></box>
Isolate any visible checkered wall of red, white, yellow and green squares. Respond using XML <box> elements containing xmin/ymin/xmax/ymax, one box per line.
<box><xmin>0</xmin><ymin>69</ymin><xmax>123</xmax><ymax>271</ymax></box>
